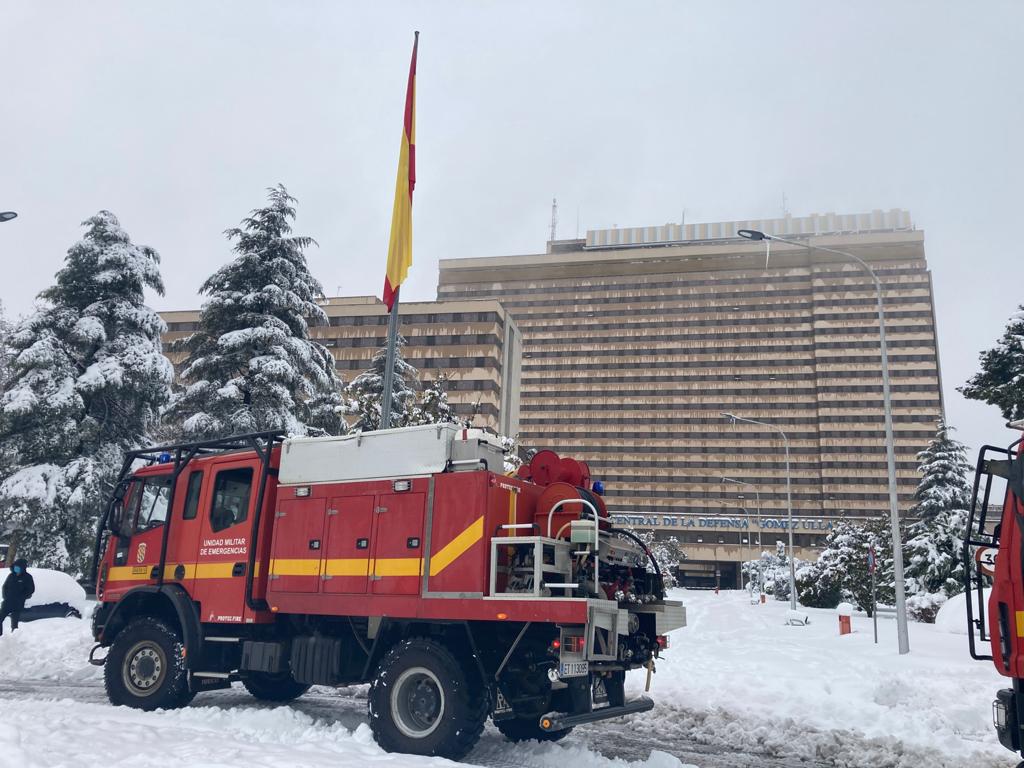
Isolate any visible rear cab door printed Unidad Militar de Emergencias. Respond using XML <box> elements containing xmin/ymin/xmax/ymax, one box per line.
<box><xmin>193</xmin><ymin>457</ymin><xmax>260</xmax><ymax>623</ymax></box>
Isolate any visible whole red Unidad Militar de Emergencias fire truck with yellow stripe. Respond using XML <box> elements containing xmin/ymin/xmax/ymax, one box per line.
<box><xmin>90</xmin><ymin>424</ymin><xmax>685</xmax><ymax>759</ymax></box>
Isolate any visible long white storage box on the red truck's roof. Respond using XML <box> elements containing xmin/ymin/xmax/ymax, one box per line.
<box><xmin>278</xmin><ymin>424</ymin><xmax>504</xmax><ymax>485</ymax></box>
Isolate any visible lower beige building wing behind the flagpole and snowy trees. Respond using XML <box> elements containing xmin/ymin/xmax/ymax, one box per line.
<box><xmin>161</xmin><ymin>296</ymin><xmax>522</xmax><ymax>434</ymax></box>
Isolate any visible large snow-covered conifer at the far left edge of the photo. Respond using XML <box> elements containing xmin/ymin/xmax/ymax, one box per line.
<box><xmin>0</xmin><ymin>211</ymin><xmax>174</xmax><ymax>571</ymax></box>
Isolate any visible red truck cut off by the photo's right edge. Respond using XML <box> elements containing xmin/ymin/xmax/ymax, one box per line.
<box><xmin>963</xmin><ymin>430</ymin><xmax>1024</xmax><ymax>752</ymax></box>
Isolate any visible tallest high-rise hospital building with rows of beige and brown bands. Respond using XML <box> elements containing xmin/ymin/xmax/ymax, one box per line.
<box><xmin>437</xmin><ymin>211</ymin><xmax>942</xmax><ymax>586</ymax></box>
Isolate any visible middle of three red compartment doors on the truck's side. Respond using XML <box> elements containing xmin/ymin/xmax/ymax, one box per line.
<box><xmin>323</xmin><ymin>496</ymin><xmax>374</xmax><ymax>595</ymax></box>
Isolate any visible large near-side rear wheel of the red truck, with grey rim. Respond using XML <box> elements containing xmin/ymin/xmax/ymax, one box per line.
<box><xmin>370</xmin><ymin>638</ymin><xmax>490</xmax><ymax>760</ymax></box>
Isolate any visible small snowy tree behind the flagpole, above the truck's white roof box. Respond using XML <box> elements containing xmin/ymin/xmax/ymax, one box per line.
<box><xmin>345</xmin><ymin>334</ymin><xmax>420</xmax><ymax>432</ymax></box>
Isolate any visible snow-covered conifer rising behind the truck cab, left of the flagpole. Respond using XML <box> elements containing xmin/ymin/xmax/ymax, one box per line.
<box><xmin>167</xmin><ymin>184</ymin><xmax>340</xmax><ymax>439</ymax></box>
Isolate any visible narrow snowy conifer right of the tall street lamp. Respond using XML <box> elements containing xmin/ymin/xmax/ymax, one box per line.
<box><xmin>904</xmin><ymin>419</ymin><xmax>973</xmax><ymax>597</ymax></box>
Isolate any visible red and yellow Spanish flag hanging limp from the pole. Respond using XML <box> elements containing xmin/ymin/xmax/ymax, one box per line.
<box><xmin>383</xmin><ymin>32</ymin><xmax>420</xmax><ymax>311</ymax></box>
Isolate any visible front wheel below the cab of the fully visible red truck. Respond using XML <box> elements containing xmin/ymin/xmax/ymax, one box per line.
<box><xmin>103</xmin><ymin>616</ymin><xmax>195</xmax><ymax>711</ymax></box>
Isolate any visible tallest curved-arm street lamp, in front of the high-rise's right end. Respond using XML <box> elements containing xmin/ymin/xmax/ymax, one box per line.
<box><xmin>736</xmin><ymin>229</ymin><xmax>910</xmax><ymax>653</ymax></box>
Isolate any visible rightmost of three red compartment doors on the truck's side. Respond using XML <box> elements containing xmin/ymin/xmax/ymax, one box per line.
<box><xmin>371</xmin><ymin>493</ymin><xmax>425</xmax><ymax>595</ymax></box>
